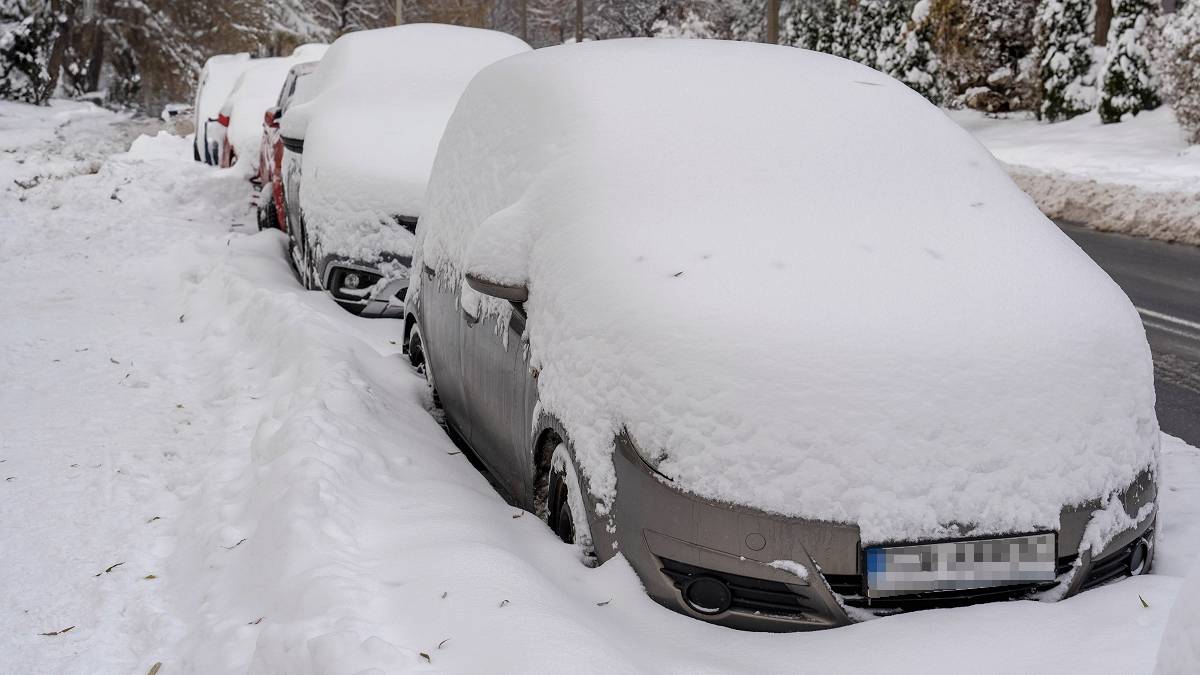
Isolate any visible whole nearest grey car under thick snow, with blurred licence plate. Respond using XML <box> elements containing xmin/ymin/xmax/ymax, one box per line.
<box><xmin>406</xmin><ymin>40</ymin><xmax>1159</xmax><ymax>631</ymax></box>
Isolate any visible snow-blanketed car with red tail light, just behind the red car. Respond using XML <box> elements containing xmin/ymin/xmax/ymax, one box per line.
<box><xmin>217</xmin><ymin>44</ymin><xmax>329</xmax><ymax>169</ymax></box>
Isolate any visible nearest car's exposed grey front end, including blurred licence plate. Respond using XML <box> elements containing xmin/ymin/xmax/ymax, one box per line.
<box><xmin>604</xmin><ymin>434</ymin><xmax>1157</xmax><ymax>632</ymax></box>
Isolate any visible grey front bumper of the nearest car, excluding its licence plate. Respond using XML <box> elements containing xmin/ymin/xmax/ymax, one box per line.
<box><xmin>614</xmin><ymin>435</ymin><xmax>1157</xmax><ymax>632</ymax></box>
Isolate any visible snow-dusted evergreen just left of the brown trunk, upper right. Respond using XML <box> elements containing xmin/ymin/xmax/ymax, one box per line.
<box><xmin>1034</xmin><ymin>0</ymin><xmax>1096</xmax><ymax>121</ymax></box>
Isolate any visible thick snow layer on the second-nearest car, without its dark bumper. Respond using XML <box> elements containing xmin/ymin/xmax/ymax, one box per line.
<box><xmin>282</xmin><ymin>24</ymin><xmax>529</xmax><ymax>259</ymax></box>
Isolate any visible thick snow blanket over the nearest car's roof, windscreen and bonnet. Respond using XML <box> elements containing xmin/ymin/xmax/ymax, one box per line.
<box><xmin>419</xmin><ymin>40</ymin><xmax>1158</xmax><ymax>543</ymax></box>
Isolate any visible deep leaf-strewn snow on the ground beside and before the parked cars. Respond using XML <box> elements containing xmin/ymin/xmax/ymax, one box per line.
<box><xmin>0</xmin><ymin>103</ymin><xmax>1200</xmax><ymax>675</ymax></box>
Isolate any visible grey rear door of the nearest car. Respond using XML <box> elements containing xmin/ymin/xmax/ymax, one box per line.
<box><xmin>418</xmin><ymin>265</ymin><xmax>474</xmax><ymax>448</ymax></box>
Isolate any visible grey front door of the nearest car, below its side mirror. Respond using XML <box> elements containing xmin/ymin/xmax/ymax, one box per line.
<box><xmin>462</xmin><ymin>290</ymin><xmax>530</xmax><ymax>498</ymax></box>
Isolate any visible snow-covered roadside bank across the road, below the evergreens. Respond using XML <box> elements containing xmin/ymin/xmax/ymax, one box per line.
<box><xmin>947</xmin><ymin>106</ymin><xmax>1200</xmax><ymax>245</ymax></box>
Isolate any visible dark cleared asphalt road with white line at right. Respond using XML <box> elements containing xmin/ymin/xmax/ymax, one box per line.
<box><xmin>1058</xmin><ymin>222</ymin><xmax>1200</xmax><ymax>446</ymax></box>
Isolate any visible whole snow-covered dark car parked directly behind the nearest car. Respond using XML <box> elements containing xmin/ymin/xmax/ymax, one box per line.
<box><xmin>281</xmin><ymin>24</ymin><xmax>529</xmax><ymax>317</ymax></box>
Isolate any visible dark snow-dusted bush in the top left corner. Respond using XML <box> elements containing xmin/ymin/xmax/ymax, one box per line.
<box><xmin>0</xmin><ymin>0</ymin><xmax>59</xmax><ymax>103</ymax></box>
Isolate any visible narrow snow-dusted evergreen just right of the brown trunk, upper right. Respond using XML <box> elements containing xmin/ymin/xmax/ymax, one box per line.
<box><xmin>1098</xmin><ymin>0</ymin><xmax>1162</xmax><ymax>124</ymax></box>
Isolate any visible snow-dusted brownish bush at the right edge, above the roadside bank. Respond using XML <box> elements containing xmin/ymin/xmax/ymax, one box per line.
<box><xmin>1158</xmin><ymin>0</ymin><xmax>1200</xmax><ymax>143</ymax></box>
